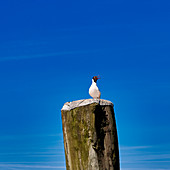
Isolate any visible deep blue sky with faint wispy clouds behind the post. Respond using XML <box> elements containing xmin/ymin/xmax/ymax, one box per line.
<box><xmin>0</xmin><ymin>0</ymin><xmax>170</xmax><ymax>170</ymax></box>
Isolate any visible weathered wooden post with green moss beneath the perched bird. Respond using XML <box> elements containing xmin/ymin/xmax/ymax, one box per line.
<box><xmin>61</xmin><ymin>99</ymin><xmax>120</xmax><ymax>170</ymax></box>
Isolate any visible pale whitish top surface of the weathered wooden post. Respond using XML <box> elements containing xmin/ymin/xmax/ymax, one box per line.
<box><xmin>61</xmin><ymin>99</ymin><xmax>113</xmax><ymax>110</ymax></box>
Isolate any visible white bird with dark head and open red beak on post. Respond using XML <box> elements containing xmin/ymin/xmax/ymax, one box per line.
<box><xmin>89</xmin><ymin>76</ymin><xmax>101</xmax><ymax>99</ymax></box>
